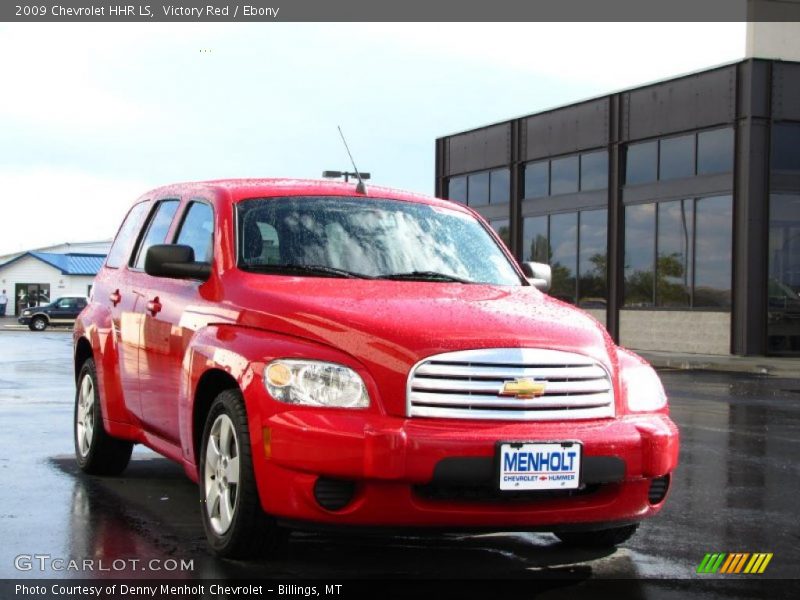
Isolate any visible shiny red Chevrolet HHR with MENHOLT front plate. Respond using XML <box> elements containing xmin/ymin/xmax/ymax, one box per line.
<box><xmin>74</xmin><ymin>180</ymin><xmax>678</xmax><ymax>557</ymax></box>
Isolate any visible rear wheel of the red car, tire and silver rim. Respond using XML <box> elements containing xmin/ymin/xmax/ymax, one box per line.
<box><xmin>72</xmin><ymin>358</ymin><xmax>133</xmax><ymax>475</ymax></box>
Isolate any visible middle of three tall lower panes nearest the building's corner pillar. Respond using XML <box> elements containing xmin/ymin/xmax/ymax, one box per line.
<box><xmin>656</xmin><ymin>200</ymin><xmax>694</xmax><ymax>307</ymax></box>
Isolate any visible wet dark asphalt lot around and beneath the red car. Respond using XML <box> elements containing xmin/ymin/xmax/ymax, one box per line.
<box><xmin>0</xmin><ymin>331</ymin><xmax>800</xmax><ymax>598</ymax></box>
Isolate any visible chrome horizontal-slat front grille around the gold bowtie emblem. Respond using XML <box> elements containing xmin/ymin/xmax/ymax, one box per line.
<box><xmin>407</xmin><ymin>348</ymin><xmax>614</xmax><ymax>421</ymax></box>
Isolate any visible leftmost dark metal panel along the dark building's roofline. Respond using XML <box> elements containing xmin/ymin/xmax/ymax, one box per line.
<box><xmin>444</xmin><ymin>122</ymin><xmax>511</xmax><ymax>176</ymax></box>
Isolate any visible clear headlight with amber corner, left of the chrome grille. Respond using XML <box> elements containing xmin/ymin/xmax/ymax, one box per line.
<box><xmin>264</xmin><ymin>359</ymin><xmax>369</xmax><ymax>408</ymax></box>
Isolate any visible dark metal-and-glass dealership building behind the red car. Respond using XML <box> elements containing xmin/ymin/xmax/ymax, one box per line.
<box><xmin>436</xmin><ymin>55</ymin><xmax>800</xmax><ymax>355</ymax></box>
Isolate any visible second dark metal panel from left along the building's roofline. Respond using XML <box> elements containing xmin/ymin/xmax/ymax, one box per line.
<box><xmin>521</xmin><ymin>97</ymin><xmax>611</xmax><ymax>160</ymax></box>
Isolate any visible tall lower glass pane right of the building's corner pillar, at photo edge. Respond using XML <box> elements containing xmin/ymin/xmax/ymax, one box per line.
<box><xmin>767</xmin><ymin>194</ymin><xmax>800</xmax><ymax>355</ymax></box>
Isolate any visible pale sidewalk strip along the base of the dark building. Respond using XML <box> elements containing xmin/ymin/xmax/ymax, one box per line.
<box><xmin>635</xmin><ymin>350</ymin><xmax>800</xmax><ymax>379</ymax></box>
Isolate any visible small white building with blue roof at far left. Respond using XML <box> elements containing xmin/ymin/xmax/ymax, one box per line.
<box><xmin>0</xmin><ymin>241</ymin><xmax>111</xmax><ymax>316</ymax></box>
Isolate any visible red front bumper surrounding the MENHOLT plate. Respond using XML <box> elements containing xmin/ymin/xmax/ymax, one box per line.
<box><xmin>253</xmin><ymin>410</ymin><xmax>679</xmax><ymax>530</ymax></box>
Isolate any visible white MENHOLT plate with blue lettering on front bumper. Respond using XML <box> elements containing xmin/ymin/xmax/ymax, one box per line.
<box><xmin>499</xmin><ymin>442</ymin><xmax>581</xmax><ymax>491</ymax></box>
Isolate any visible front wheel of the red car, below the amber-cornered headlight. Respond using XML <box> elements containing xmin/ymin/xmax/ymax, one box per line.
<box><xmin>198</xmin><ymin>390</ymin><xmax>288</xmax><ymax>559</ymax></box>
